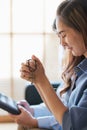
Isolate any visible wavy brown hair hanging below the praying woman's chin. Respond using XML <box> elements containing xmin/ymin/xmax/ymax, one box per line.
<box><xmin>60</xmin><ymin>50</ymin><xmax>85</xmax><ymax>95</ymax></box>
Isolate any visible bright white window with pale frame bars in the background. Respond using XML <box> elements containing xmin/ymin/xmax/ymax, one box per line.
<box><xmin>0</xmin><ymin>0</ymin><xmax>61</xmax><ymax>104</ymax></box>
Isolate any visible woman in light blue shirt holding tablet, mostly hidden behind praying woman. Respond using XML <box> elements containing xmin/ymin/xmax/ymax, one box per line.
<box><xmin>9</xmin><ymin>50</ymin><xmax>84</xmax><ymax>130</ymax></box>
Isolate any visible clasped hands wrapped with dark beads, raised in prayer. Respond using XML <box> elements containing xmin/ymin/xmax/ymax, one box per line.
<box><xmin>20</xmin><ymin>55</ymin><xmax>45</xmax><ymax>83</ymax></box>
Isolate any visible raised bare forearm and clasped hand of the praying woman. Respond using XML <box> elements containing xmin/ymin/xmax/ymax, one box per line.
<box><xmin>21</xmin><ymin>56</ymin><xmax>68</xmax><ymax>124</ymax></box>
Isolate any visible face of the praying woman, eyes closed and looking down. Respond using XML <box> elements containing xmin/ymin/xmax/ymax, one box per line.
<box><xmin>56</xmin><ymin>20</ymin><xmax>87</xmax><ymax>57</ymax></box>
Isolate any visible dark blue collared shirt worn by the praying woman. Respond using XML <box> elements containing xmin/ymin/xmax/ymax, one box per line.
<box><xmin>61</xmin><ymin>58</ymin><xmax>87</xmax><ymax>130</ymax></box>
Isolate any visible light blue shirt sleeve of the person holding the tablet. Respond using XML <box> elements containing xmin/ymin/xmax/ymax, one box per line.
<box><xmin>31</xmin><ymin>103</ymin><xmax>61</xmax><ymax>130</ymax></box>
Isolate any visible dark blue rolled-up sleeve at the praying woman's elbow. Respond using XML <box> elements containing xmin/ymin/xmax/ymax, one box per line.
<box><xmin>62</xmin><ymin>89</ymin><xmax>87</xmax><ymax>130</ymax></box>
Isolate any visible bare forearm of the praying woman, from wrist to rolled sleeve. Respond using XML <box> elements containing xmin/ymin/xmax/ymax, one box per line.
<box><xmin>35</xmin><ymin>77</ymin><xmax>67</xmax><ymax>124</ymax></box>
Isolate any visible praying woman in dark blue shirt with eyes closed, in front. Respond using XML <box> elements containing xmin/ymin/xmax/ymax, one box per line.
<box><xmin>9</xmin><ymin>1</ymin><xmax>87</xmax><ymax>130</ymax></box>
